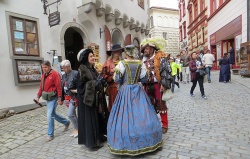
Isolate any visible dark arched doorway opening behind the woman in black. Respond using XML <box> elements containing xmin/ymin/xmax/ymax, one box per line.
<box><xmin>64</xmin><ymin>27</ymin><xmax>84</xmax><ymax>70</ymax></box>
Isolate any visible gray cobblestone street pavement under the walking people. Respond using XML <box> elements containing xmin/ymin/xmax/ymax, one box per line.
<box><xmin>0</xmin><ymin>72</ymin><xmax>250</xmax><ymax>159</ymax></box>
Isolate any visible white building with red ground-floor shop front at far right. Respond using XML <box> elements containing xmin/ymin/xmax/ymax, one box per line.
<box><xmin>208</xmin><ymin>0</ymin><xmax>248</xmax><ymax>68</ymax></box>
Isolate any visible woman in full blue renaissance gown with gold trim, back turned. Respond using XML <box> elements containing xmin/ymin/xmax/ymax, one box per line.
<box><xmin>107</xmin><ymin>45</ymin><xmax>162</xmax><ymax>156</ymax></box>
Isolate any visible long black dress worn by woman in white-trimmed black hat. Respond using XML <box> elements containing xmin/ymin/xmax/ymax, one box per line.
<box><xmin>77</xmin><ymin>65</ymin><xmax>109</xmax><ymax>148</ymax></box>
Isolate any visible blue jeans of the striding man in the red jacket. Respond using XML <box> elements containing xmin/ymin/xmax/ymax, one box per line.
<box><xmin>46</xmin><ymin>98</ymin><xmax>69</xmax><ymax>137</ymax></box>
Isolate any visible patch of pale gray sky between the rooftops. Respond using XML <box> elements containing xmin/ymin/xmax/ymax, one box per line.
<box><xmin>150</xmin><ymin>0</ymin><xmax>178</xmax><ymax>9</ymax></box>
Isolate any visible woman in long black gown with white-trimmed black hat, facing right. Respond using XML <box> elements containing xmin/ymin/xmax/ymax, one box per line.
<box><xmin>77</xmin><ymin>49</ymin><xmax>109</xmax><ymax>149</ymax></box>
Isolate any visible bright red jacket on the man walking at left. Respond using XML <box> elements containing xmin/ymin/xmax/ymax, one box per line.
<box><xmin>37</xmin><ymin>70</ymin><xmax>62</xmax><ymax>98</ymax></box>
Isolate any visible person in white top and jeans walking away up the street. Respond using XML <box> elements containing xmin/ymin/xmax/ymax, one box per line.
<box><xmin>202</xmin><ymin>50</ymin><xmax>215</xmax><ymax>83</ymax></box>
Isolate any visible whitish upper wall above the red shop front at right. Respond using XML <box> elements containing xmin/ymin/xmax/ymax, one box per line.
<box><xmin>208</xmin><ymin>0</ymin><xmax>247</xmax><ymax>42</ymax></box>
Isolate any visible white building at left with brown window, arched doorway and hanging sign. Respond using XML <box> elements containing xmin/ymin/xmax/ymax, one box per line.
<box><xmin>0</xmin><ymin>0</ymin><xmax>149</xmax><ymax>109</ymax></box>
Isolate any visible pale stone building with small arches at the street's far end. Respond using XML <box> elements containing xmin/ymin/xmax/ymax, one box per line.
<box><xmin>149</xmin><ymin>6</ymin><xmax>179</xmax><ymax>56</ymax></box>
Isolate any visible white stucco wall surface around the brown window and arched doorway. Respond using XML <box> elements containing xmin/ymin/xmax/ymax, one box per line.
<box><xmin>0</xmin><ymin>0</ymin><xmax>148</xmax><ymax>109</ymax></box>
